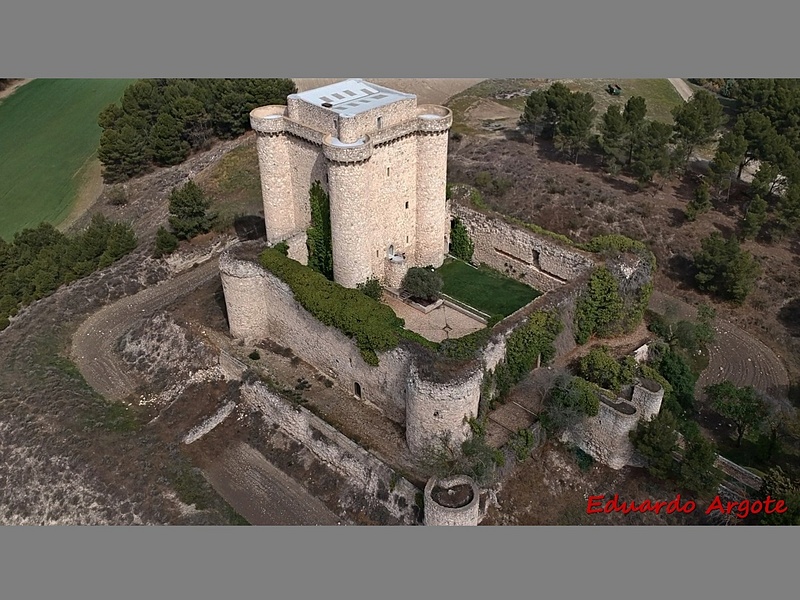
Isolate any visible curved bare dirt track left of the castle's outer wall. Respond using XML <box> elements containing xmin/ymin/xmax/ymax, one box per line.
<box><xmin>70</xmin><ymin>259</ymin><xmax>219</xmax><ymax>400</ymax></box>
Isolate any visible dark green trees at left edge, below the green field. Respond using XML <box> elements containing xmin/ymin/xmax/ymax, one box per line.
<box><xmin>0</xmin><ymin>214</ymin><xmax>137</xmax><ymax>329</ymax></box>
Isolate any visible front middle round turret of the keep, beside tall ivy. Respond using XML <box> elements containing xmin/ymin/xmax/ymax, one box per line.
<box><xmin>322</xmin><ymin>135</ymin><xmax>374</xmax><ymax>288</ymax></box>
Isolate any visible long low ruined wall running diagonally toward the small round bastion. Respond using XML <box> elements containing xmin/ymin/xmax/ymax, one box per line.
<box><xmin>242</xmin><ymin>383</ymin><xmax>420</xmax><ymax>525</ymax></box>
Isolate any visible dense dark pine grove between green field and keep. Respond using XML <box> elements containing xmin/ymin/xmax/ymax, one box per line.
<box><xmin>98</xmin><ymin>79</ymin><xmax>297</xmax><ymax>183</ymax></box>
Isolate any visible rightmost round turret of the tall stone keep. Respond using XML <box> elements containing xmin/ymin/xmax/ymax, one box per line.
<box><xmin>416</xmin><ymin>104</ymin><xmax>453</xmax><ymax>267</ymax></box>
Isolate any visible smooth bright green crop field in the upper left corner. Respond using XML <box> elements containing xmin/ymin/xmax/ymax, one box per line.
<box><xmin>0</xmin><ymin>79</ymin><xmax>134</xmax><ymax>241</ymax></box>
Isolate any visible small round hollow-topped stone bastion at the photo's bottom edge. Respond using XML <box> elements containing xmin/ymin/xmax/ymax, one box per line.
<box><xmin>424</xmin><ymin>475</ymin><xmax>480</xmax><ymax>526</ymax></box>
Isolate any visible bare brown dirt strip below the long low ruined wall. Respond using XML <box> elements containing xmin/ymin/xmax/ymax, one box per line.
<box><xmin>201</xmin><ymin>442</ymin><xmax>340</xmax><ymax>525</ymax></box>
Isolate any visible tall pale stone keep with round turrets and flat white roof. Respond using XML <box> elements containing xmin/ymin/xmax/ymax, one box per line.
<box><xmin>250</xmin><ymin>79</ymin><xmax>453</xmax><ymax>288</ymax></box>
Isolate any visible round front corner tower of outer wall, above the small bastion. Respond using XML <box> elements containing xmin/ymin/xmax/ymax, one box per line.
<box><xmin>406</xmin><ymin>365</ymin><xmax>483</xmax><ymax>455</ymax></box>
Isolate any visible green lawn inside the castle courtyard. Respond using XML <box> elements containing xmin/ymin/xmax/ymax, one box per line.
<box><xmin>437</xmin><ymin>258</ymin><xmax>542</xmax><ymax>317</ymax></box>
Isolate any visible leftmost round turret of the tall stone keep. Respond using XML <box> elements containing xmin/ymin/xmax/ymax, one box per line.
<box><xmin>250</xmin><ymin>105</ymin><xmax>295</xmax><ymax>244</ymax></box>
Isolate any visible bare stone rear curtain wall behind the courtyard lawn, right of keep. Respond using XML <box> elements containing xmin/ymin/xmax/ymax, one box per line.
<box><xmin>451</xmin><ymin>202</ymin><xmax>595</xmax><ymax>292</ymax></box>
